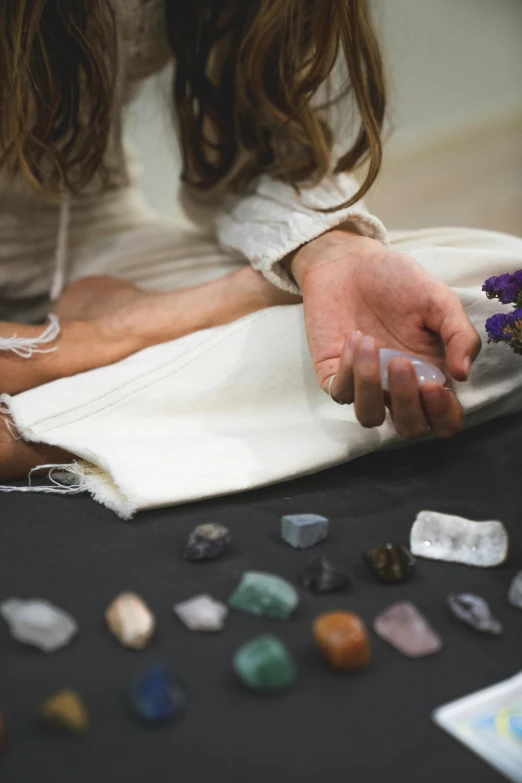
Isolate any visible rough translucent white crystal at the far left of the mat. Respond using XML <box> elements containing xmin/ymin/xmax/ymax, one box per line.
<box><xmin>0</xmin><ymin>598</ymin><xmax>78</xmax><ymax>652</ymax></box>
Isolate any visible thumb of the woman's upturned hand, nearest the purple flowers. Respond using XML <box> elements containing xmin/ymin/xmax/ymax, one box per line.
<box><xmin>428</xmin><ymin>286</ymin><xmax>482</xmax><ymax>381</ymax></box>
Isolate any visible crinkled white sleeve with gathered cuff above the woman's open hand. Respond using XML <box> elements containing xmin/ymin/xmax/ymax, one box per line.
<box><xmin>181</xmin><ymin>168</ymin><xmax>389</xmax><ymax>294</ymax></box>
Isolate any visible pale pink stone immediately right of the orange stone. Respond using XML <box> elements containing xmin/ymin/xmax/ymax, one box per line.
<box><xmin>373</xmin><ymin>601</ymin><xmax>442</xmax><ymax>658</ymax></box>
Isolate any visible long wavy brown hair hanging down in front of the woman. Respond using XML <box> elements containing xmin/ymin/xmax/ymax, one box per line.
<box><xmin>0</xmin><ymin>0</ymin><xmax>385</xmax><ymax>203</ymax></box>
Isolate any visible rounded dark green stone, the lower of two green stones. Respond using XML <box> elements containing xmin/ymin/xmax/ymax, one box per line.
<box><xmin>234</xmin><ymin>634</ymin><xmax>297</xmax><ymax>691</ymax></box>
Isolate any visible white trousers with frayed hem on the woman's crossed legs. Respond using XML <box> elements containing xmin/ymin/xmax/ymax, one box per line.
<box><xmin>2</xmin><ymin>221</ymin><xmax>522</xmax><ymax>519</ymax></box>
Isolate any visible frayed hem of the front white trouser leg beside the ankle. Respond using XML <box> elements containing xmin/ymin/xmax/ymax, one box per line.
<box><xmin>0</xmin><ymin>394</ymin><xmax>137</xmax><ymax>521</ymax></box>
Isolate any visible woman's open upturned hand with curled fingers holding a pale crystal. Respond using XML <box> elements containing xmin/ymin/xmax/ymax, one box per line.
<box><xmin>290</xmin><ymin>230</ymin><xmax>481</xmax><ymax>438</ymax></box>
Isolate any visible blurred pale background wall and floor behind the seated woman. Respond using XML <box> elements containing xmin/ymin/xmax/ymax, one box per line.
<box><xmin>129</xmin><ymin>0</ymin><xmax>522</xmax><ymax>233</ymax></box>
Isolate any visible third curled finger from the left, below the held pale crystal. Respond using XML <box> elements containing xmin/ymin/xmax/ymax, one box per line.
<box><xmin>388</xmin><ymin>358</ymin><xmax>428</xmax><ymax>438</ymax></box>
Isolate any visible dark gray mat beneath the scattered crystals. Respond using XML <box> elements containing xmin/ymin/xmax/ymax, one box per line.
<box><xmin>0</xmin><ymin>416</ymin><xmax>522</xmax><ymax>783</ymax></box>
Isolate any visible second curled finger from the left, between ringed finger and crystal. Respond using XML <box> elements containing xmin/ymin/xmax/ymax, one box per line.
<box><xmin>353</xmin><ymin>335</ymin><xmax>386</xmax><ymax>427</ymax></box>
